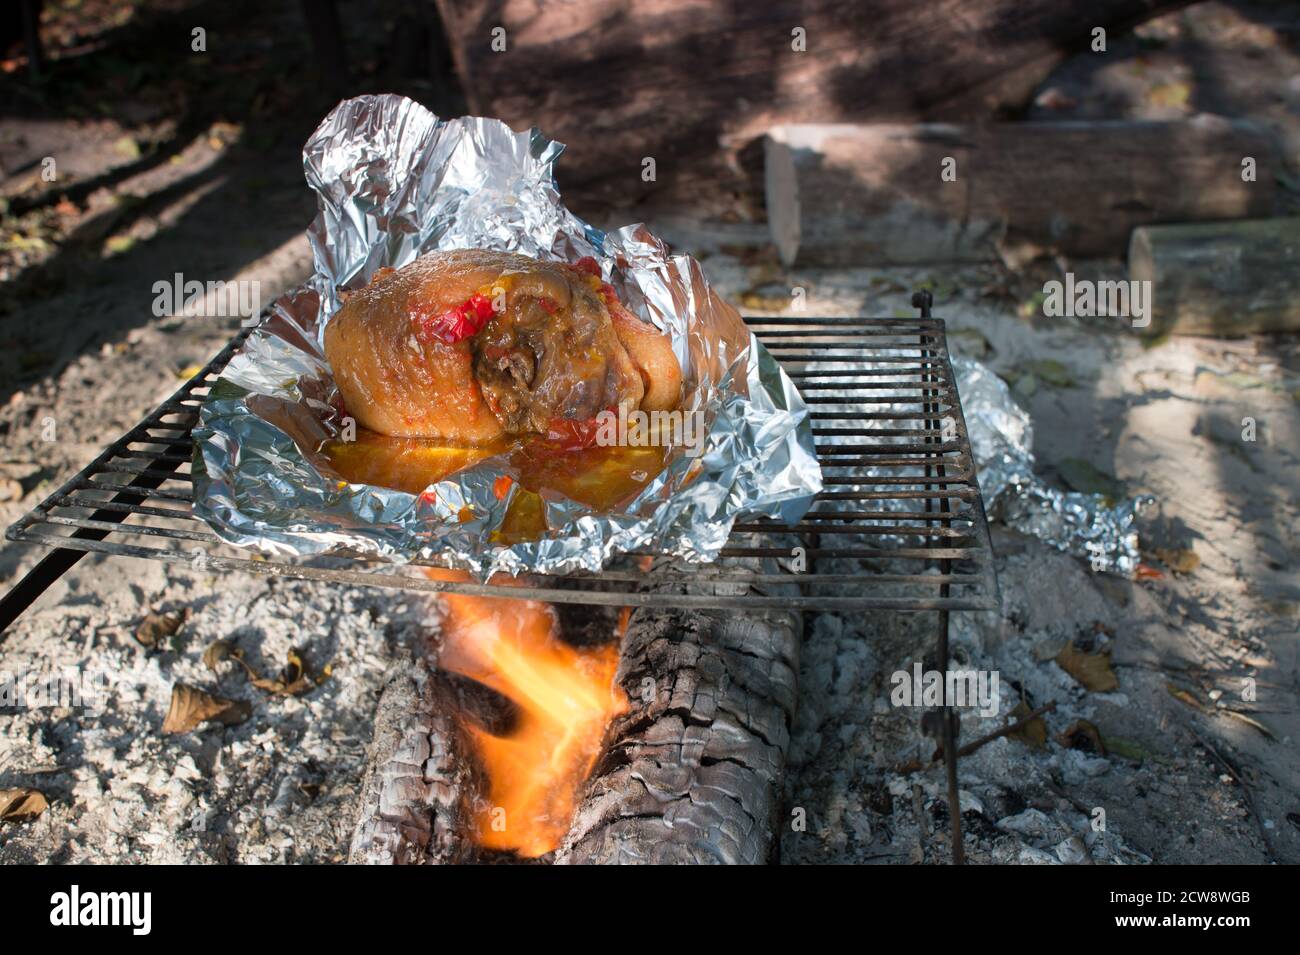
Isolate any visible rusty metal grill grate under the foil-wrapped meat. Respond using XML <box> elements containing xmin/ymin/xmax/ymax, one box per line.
<box><xmin>8</xmin><ymin>310</ymin><xmax>997</xmax><ymax>611</ymax></box>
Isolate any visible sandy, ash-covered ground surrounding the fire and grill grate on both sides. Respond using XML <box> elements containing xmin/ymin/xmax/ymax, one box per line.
<box><xmin>0</xmin><ymin>4</ymin><xmax>1300</xmax><ymax>863</ymax></box>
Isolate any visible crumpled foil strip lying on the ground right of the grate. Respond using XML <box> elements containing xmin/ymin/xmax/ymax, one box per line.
<box><xmin>953</xmin><ymin>359</ymin><xmax>1151</xmax><ymax>576</ymax></box>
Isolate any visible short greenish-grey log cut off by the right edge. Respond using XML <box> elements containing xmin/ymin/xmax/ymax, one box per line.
<box><xmin>1128</xmin><ymin>217</ymin><xmax>1300</xmax><ymax>335</ymax></box>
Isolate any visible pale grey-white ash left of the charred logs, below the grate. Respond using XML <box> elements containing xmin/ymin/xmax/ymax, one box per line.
<box><xmin>0</xmin><ymin>572</ymin><xmax>434</xmax><ymax>864</ymax></box>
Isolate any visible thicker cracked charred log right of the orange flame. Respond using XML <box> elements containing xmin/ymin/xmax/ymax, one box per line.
<box><xmin>556</xmin><ymin>594</ymin><xmax>801</xmax><ymax>864</ymax></box>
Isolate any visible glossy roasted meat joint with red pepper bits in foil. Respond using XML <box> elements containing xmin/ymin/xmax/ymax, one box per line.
<box><xmin>325</xmin><ymin>249</ymin><xmax>681</xmax><ymax>444</ymax></box>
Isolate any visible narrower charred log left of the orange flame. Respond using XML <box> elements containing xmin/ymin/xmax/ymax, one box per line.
<box><xmin>350</xmin><ymin>654</ymin><xmax>473</xmax><ymax>865</ymax></box>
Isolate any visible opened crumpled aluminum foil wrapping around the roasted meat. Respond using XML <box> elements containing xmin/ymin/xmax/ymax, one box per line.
<box><xmin>194</xmin><ymin>95</ymin><xmax>822</xmax><ymax>578</ymax></box>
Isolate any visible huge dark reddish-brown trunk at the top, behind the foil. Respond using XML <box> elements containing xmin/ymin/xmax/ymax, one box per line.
<box><xmin>438</xmin><ymin>0</ymin><xmax>1186</xmax><ymax>208</ymax></box>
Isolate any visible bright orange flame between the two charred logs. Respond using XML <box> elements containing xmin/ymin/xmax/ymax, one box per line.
<box><xmin>428</xmin><ymin>568</ymin><xmax>628</xmax><ymax>859</ymax></box>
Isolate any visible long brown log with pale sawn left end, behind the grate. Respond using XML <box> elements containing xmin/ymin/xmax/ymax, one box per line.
<box><xmin>766</xmin><ymin>116</ymin><xmax>1281</xmax><ymax>266</ymax></box>
